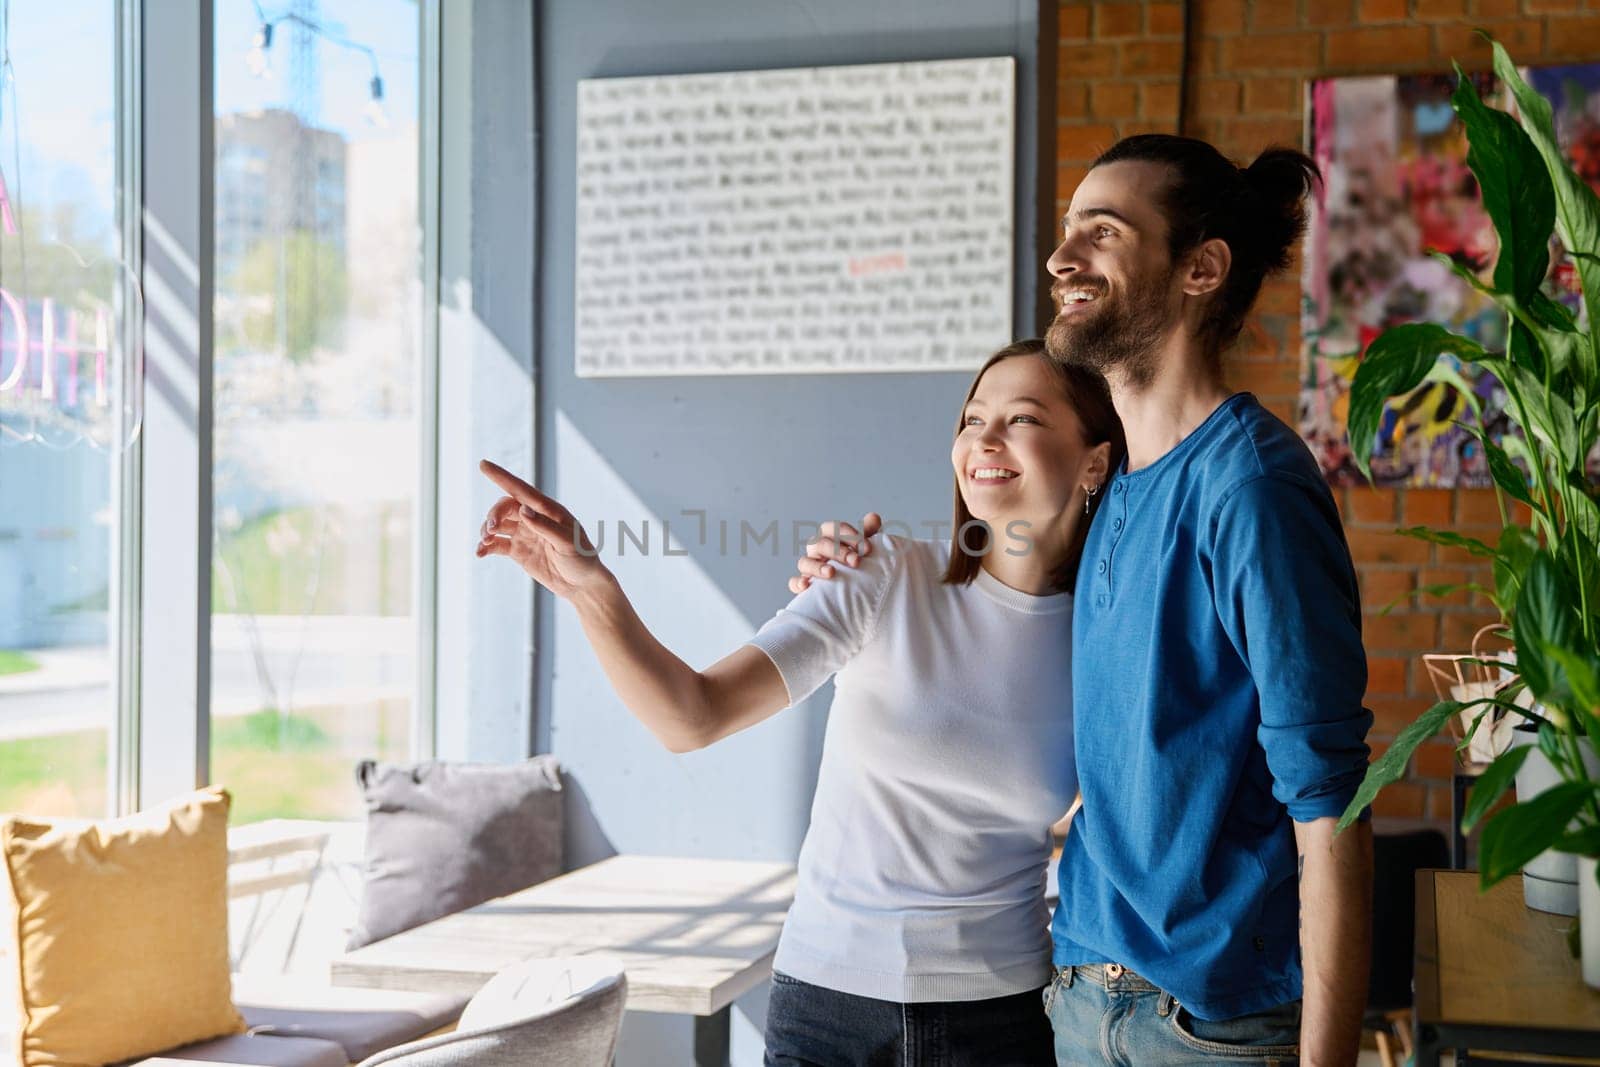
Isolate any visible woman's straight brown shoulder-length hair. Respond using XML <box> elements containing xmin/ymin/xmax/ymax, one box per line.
<box><xmin>944</xmin><ymin>338</ymin><xmax>1128</xmax><ymax>592</ymax></box>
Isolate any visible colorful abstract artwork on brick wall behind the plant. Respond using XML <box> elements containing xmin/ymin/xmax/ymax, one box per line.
<box><xmin>1299</xmin><ymin>64</ymin><xmax>1600</xmax><ymax>488</ymax></box>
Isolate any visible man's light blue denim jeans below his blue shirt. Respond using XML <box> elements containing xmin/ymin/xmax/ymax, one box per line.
<box><xmin>1045</xmin><ymin>963</ymin><xmax>1301</xmax><ymax>1067</ymax></box>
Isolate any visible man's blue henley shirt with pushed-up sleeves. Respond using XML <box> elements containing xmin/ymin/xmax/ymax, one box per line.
<box><xmin>1051</xmin><ymin>394</ymin><xmax>1371</xmax><ymax>1019</ymax></box>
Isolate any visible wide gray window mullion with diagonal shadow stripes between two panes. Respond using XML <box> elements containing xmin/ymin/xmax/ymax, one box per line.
<box><xmin>138</xmin><ymin>0</ymin><xmax>214</xmax><ymax>806</ymax></box>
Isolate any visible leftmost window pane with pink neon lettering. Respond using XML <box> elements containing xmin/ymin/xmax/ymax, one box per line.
<box><xmin>0</xmin><ymin>0</ymin><xmax>124</xmax><ymax>817</ymax></box>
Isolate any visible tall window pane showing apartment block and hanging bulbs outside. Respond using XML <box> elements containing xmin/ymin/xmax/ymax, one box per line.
<box><xmin>211</xmin><ymin>0</ymin><xmax>422</xmax><ymax>822</ymax></box>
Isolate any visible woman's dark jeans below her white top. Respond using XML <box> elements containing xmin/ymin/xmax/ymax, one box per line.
<box><xmin>766</xmin><ymin>971</ymin><xmax>1056</xmax><ymax>1067</ymax></box>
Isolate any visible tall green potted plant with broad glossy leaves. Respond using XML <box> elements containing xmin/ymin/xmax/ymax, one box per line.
<box><xmin>1339</xmin><ymin>42</ymin><xmax>1600</xmax><ymax>985</ymax></box>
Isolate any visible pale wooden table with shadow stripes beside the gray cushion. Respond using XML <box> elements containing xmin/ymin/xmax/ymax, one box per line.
<box><xmin>333</xmin><ymin>856</ymin><xmax>795</xmax><ymax>1067</ymax></box>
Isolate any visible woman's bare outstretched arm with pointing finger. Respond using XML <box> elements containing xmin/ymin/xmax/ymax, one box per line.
<box><xmin>477</xmin><ymin>459</ymin><xmax>789</xmax><ymax>752</ymax></box>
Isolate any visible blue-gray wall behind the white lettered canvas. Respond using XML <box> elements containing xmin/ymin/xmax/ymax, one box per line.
<box><xmin>536</xmin><ymin>0</ymin><xmax>1054</xmax><ymax>1062</ymax></box>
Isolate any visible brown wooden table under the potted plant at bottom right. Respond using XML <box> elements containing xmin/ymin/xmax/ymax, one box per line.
<box><xmin>1416</xmin><ymin>870</ymin><xmax>1600</xmax><ymax>1064</ymax></box>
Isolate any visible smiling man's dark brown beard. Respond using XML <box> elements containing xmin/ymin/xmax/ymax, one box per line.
<box><xmin>1045</xmin><ymin>267</ymin><xmax>1171</xmax><ymax>389</ymax></box>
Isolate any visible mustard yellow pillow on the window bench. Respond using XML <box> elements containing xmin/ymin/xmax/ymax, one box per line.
<box><xmin>0</xmin><ymin>785</ymin><xmax>245</xmax><ymax>1067</ymax></box>
